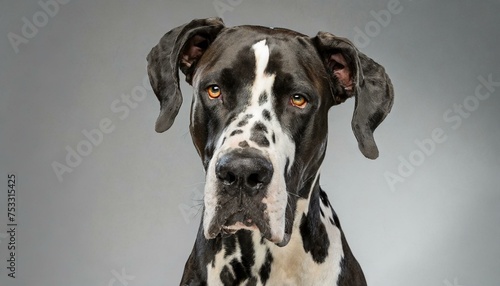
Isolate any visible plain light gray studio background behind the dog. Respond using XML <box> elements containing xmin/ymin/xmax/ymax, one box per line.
<box><xmin>0</xmin><ymin>0</ymin><xmax>500</xmax><ymax>286</ymax></box>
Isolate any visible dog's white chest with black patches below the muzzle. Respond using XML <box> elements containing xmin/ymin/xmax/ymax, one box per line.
<box><xmin>207</xmin><ymin>198</ymin><xmax>343</xmax><ymax>286</ymax></box>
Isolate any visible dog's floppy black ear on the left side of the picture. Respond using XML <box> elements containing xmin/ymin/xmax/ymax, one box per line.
<box><xmin>147</xmin><ymin>18</ymin><xmax>224</xmax><ymax>133</ymax></box>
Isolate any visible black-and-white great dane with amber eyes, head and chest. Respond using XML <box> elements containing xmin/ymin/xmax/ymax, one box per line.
<box><xmin>147</xmin><ymin>18</ymin><xmax>393</xmax><ymax>286</ymax></box>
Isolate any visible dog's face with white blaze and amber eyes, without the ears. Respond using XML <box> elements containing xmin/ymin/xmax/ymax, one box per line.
<box><xmin>191</xmin><ymin>27</ymin><xmax>333</xmax><ymax>243</ymax></box>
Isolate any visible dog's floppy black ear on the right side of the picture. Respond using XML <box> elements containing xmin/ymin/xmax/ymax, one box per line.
<box><xmin>312</xmin><ymin>32</ymin><xmax>394</xmax><ymax>159</ymax></box>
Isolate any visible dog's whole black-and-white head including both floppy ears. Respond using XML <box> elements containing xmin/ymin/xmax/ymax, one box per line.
<box><xmin>148</xmin><ymin>18</ymin><xmax>393</xmax><ymax>245</ymax></box>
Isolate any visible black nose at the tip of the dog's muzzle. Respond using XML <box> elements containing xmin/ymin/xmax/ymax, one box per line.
<box><xmin>215</xmin><ymin>148</ymin><xmax>273</xmax><ymax>196</ymax></box>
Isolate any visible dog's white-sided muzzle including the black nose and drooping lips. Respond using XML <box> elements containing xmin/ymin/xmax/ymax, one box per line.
<box><xmin>204</xmin><ymin>147</ymin><xmax>286</xmax><ymax>243</ymax></box>
